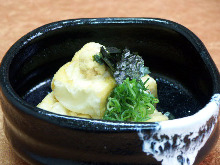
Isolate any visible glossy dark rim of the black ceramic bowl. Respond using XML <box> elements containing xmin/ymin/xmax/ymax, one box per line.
<box><xmin>0</xmin><ymin>17</ymin><xmax>220</xmax><ymax>131</ymax></box>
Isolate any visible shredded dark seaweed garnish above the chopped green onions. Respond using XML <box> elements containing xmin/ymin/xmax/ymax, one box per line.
<box><xmin>94</xmin><ymin>47</ymin><xmax>150</xmax><ymax>84</ymax></box>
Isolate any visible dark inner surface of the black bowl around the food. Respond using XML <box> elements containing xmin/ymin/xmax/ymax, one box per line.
<box><xmin>9</xmin><ymin>21</ymin><xmax>213</xmax><ymax>118</ymax></box>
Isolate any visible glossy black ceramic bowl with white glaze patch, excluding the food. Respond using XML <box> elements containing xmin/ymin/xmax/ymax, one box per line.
<box><xmin>0</xmin><ymin>18</ymin><xmax>220</xmax><ymax>165</ymax></box>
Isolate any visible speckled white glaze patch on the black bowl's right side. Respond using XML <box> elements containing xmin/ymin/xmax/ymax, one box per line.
<box><xmin>138</xmin><ymin>94</ymin><xmax>220</xmax><ymax>165</ymax></box>
